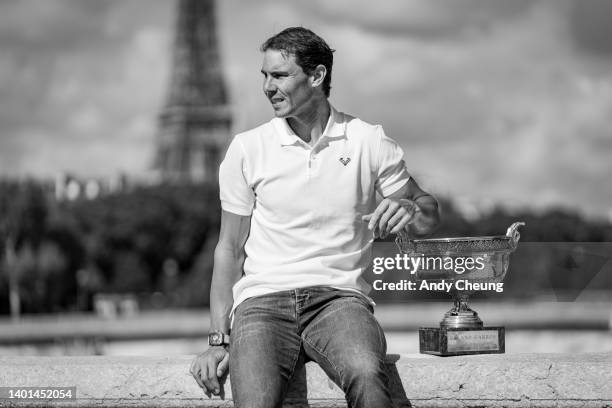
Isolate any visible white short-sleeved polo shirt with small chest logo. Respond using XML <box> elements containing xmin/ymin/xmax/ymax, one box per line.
<box><xmin>219</xmin><ymin>107</ymin><xmax>410</xmax><ymax>309</ymax></box>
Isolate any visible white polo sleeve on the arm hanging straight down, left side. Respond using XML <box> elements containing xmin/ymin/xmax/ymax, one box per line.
<box><xmin>219</xmin><ymin>137</ymin><xmax>255</xmax><ymax>216</ymax></box>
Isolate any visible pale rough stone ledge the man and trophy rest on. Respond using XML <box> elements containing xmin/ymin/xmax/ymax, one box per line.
<box><xmin>0</xmin><ymin>353</ymin><xmax>612</xmax><ymax>407</ymax></box>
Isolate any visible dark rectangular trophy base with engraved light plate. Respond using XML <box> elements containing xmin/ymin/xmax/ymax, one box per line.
<box><xmin>419</xmin><ymin>327</ymin><xmax>506</xmax><ymax>357</ymax></box>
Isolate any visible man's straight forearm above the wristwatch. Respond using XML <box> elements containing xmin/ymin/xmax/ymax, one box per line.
<box><xmin>210</xmin><ymin>246</ymin><xmax>244</xmax><ymax>333</ymax></box>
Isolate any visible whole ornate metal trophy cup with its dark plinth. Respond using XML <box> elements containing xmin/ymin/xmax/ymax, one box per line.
<box><xmin>396</xmin><ymin>222</ymin><xmax>525</xmax><ymax>355</ymax></box>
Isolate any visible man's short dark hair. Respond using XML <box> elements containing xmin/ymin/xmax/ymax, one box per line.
<box><xmin>260</xmin><ymin>27</ymin><xmax>335</xmax><ymax>97</ymax></box>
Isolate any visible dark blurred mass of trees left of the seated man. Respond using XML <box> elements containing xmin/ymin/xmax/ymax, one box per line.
<box><xmin>0</xmin><ymin>181</ymin><xmax>220</xmax><ymax>313</ymax></box>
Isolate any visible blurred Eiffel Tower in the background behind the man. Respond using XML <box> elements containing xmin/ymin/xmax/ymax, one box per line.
<box><xmin>154</xmin><ymin>0</ymin><xmax>232</xmax><ymax>183</ymax></box>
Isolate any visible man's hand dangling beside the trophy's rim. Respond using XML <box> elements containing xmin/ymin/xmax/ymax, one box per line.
<box><xmin>361</xmin><ymin>197</ymin><xmax>420</xmax><ymax>238</ymax></box>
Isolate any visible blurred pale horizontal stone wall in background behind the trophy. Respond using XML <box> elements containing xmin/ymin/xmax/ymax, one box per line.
<box><xmin>0</xmin><ymin>298</ymin><xmax>612</xmax><ymax>345</ymax></box>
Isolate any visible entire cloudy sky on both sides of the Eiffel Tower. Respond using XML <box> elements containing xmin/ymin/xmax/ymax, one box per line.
<box><xmin>0</xmin><ymin>0</ymin><xmax>612</xmax><ymax>218</ymax></box>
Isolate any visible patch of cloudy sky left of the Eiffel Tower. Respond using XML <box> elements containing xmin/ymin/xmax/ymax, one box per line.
<box><xmin>0</xmin><ymin>1</ymin><xmax>171</xmax><ymax>176</ymax></box>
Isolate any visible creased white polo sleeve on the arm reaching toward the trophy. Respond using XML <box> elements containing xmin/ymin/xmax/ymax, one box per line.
<box><xmin>376</xmin><ymin>126</ymin><xmax>410</xmax><ymax>197</ymax></box>
